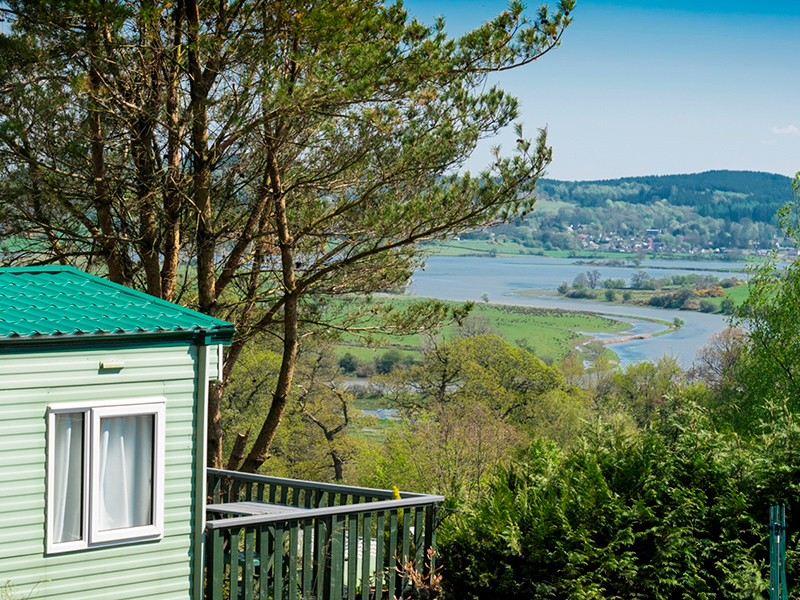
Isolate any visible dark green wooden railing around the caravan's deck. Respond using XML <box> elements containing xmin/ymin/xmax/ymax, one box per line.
<box><xmin>205</xmin><ymin>469</ymin><xmax>444</xmax><ymax>600</ymax></box>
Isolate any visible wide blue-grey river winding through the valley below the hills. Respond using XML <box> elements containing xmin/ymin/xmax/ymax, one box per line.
<box><xmin>408</xmin><ymin>256</ymin><xmax>746</xmax><ymax>368</ymax></box>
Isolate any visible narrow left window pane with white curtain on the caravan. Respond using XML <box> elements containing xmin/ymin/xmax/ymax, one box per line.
<box><xmin>51</xmin><ymin>413</ymin><xmax>84</xmax><ymax>543</ymax></box>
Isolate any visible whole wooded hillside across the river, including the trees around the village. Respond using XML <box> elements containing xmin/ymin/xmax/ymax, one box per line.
<box><xmin>482</xmin><ymin>171</ymin><xmax>791</xmax><ymax>253</ymax></box>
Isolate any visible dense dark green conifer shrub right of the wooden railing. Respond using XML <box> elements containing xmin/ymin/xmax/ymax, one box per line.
<box><xmin>440</xmin><ymin>401</ymin><xmax>800</xmax><ymax>600</ymax></box>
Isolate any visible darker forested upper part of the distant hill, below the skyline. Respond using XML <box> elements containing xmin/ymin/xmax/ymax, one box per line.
<box><xmin>536</xmin><ymin>171</ymin><xmax>792</xmax><ymax>224</ymax></box>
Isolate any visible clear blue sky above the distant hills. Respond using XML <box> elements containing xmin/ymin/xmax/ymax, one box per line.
<box><xmin>404</xmin><ymin>0</ymin><xmax>800</xmax><ymax>180</ymax></box>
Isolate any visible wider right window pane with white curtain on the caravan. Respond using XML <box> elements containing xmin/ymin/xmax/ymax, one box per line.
<box><xmin>95</xmin><ymin>415</ymin><xmax>155</xmax><ymax>531</ymax></box>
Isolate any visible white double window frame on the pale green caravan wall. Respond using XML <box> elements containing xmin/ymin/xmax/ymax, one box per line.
<box><xmin>46</xmin><ymin>397</ymin><xmax>166</xmax><ymax>554</ymax></box>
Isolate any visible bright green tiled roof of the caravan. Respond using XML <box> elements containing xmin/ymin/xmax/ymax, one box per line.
<box><xmin>0</xmin><ymin>266</ymin><xmax>234</xmax><ymax>346</ymax></box>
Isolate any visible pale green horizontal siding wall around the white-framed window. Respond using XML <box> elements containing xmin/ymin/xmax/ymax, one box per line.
<box><xmin>0</xmin><ymin>345</ymin><xmax>206</xmax><ymax>600</ymax></box>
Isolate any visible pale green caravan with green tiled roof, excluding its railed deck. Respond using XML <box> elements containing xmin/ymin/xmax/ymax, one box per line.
<box><xmin>0</xmin><ymin>267</ymin><xmax>234</xmax><ymax>600</ymax></box>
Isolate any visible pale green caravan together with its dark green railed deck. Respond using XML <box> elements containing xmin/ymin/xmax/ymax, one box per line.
<box><xmin>0</xmin><ymin>267</ymin><xmax>444</xmax><ymax>600</ymax></box>
